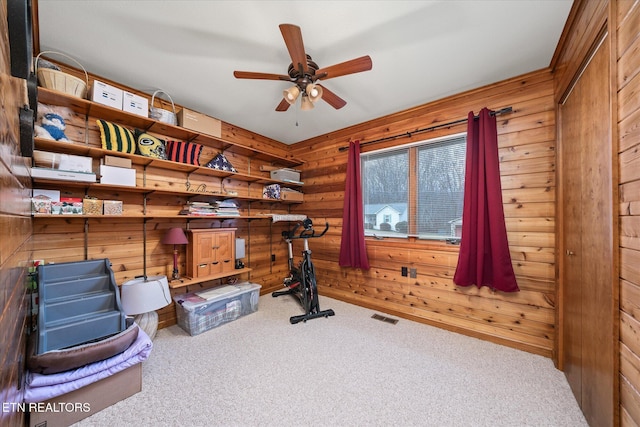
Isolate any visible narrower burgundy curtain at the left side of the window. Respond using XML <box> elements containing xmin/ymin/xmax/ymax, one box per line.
<box><xmin>339</xmin><ymin>141</ymin><xmax>369</xmax><ymax>270</ymax></box>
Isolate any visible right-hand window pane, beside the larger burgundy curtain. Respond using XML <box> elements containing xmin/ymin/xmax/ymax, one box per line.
<box><xmin>417</xmin><ymin>136</ymin><xmax>466</xmax><ymax>239</ymax></box>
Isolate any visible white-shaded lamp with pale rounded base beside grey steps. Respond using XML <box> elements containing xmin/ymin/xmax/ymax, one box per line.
<box><xmin>120</xmin><ymin>276</ymin><xmax>171</xmax><ymax>339</ymax></box>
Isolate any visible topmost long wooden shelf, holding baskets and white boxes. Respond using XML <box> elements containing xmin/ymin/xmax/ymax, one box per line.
<box><xmin>38</xmin><ymin>87</ymin><xmax>304</xmax><ymax>167</ymax></box>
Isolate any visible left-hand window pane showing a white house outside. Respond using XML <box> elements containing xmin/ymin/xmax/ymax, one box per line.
<box><xmin>360</xmin><ymin>149</ymin><xmax>409</xmax><ymax>237</ymax></box>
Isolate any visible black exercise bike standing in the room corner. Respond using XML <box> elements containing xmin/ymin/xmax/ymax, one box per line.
<box><xmin>271</xmin><ymin>218</ymin><xmax>335</xmax><ymax>324</ymax></box>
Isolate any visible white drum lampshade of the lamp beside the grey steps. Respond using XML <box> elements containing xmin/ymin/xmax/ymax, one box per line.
<box><xmin>120</xmin><ymin>276</ymin><xmax>171</xmax><ymax>316</ymax></box>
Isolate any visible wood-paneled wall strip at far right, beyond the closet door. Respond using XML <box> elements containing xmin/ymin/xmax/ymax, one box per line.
<box><xmin>612</xmin><ymin>0</ymin><xmax>640</xmax><ymax>426</ymax></box>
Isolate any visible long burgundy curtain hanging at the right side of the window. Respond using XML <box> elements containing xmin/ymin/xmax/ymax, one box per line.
<box><xmin>453</xmin><ymin>108</ymin><xmax>520</xmax><ymax>292</ymax></box>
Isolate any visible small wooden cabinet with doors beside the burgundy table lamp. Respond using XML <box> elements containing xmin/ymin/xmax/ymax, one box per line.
<box><xmin>187</xmin><ymin>228</ymin><xmax>236</xmax><ymax>279</ymax></box>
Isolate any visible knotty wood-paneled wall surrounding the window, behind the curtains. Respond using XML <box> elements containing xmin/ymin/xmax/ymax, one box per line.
<box><xmin>293</xmin><ymin>70</ymin><xmax>556</xmax><ymax>357</ymax></box>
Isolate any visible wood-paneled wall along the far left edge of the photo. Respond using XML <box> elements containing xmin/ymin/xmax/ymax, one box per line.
<box><xmin>0</xmin><ymin>0</ymin><xmax>32</xmax><ymax>426</ymax></box>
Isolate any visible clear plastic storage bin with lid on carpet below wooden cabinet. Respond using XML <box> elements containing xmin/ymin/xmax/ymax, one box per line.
<box><xmin>173</xmin><ymin>282</ymin><xmax>262</xmax><ymax>336</ymax></box>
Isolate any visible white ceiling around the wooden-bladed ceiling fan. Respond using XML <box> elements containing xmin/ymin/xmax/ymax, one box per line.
<box><xmin>38</xmin><ymin>0</ymin><xmax>572</xmax><ymax>144</ymax></box>
